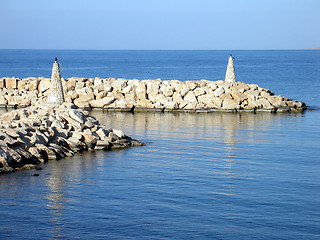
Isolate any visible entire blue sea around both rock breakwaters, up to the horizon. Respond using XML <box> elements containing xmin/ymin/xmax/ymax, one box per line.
<box><xmin>0</xmin><ymin>50</ymin><xmax>320</xmax><ymax>240</ymax></box>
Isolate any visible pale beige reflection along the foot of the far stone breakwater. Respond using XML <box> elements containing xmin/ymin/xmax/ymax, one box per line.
<box><xmin>91</xmin><ymin>111</ymin><xmax>303</xmax><ymax>151</ymax></box>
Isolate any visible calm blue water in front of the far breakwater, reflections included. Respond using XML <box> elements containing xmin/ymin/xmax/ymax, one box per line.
<box><xmin>0</xmin><ymin>111</ymin><xmax>320</xmax><ymax>239</ymax></box>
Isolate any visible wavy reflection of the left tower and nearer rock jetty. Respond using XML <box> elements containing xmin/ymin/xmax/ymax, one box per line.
<box><xmin>45</xmin><ymin>151</ymin><xmax>112</xmax><ymax>239</ymax></box>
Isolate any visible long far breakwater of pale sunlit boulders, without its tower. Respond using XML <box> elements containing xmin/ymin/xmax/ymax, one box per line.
<box><xmin>0</xmin><ymin>77</ymin><xmax>306</xmax><ymax>113</ymax></box>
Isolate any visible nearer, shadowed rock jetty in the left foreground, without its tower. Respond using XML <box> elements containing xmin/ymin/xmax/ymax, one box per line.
<box><xmin>0</xmin><ymin>102</ymin><xmax>144</xmax><ymax>173</ymax></box>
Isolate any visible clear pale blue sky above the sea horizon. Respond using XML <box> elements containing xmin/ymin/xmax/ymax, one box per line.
<box><xmin>0</xmin><ymin>0</ymin><xmax>320</xmax><ymax>49</ymax></box>
